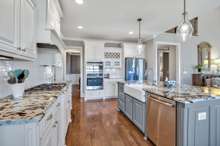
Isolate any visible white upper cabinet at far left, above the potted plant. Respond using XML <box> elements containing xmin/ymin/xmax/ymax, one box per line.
<box><xmin>0</xmin><ymin>0</ymin><xmax>36</xmax><ymax>60</ymax></box>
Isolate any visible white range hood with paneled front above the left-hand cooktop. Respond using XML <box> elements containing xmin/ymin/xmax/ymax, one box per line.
<box><xmin>37</xmin><ymin>0</ymin><xmax>63</xmax><ymax>44</ymax></box>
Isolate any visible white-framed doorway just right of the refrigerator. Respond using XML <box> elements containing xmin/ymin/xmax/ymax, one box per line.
<box><xmin>157</xmin><ymin>44</ymin><xmax>179</xmax><ymax>82</ymax></box>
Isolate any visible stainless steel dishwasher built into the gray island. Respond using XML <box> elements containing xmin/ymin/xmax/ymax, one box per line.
<box><xmin>146</xmin><ymin>94</ymin><xmax>176</xmax><ymax>146</ymax></box>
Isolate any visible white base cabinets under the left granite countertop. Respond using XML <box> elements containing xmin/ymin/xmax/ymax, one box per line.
<box><xmin>0</xmin><ymin>84</ymin><xmax>72</xmax><ymax>146</ymax></box>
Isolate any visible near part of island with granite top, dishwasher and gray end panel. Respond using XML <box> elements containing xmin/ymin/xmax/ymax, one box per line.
<box><xmin>143</xmin><ymin>84</ymin><xmax>220</xmax><ymax>146</ymax></box>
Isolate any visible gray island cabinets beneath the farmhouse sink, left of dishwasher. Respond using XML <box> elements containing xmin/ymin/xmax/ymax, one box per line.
<box><xmin>118</xmin><ymin>82</ymin><xmax>146</xmax><ymax>133</ymax></box>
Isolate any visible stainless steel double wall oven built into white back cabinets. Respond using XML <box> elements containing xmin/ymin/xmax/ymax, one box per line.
<box><xmin>86</xmin><ymin>62</ymin><xmax>104</xmax><ymax>90</ymax></box>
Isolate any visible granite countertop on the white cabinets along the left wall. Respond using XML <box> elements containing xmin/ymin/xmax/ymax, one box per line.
<box><xmin>0</xmin><ymin>83</ymin><xmax>67</xmax><ymax>125</ymax></box>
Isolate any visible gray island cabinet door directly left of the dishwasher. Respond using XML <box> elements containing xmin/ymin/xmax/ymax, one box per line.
<box><xmin>133</xmin><ymin>100</ymin><xmax>145</xmax><ymax>132</ymax></box>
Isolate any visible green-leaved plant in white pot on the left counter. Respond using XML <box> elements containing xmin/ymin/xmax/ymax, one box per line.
<box><xmin>8</xmin><ymin>69</ymin><xmax>29</xmax><ymax>99</ymax></box>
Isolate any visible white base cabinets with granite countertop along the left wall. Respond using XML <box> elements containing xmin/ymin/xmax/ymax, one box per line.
<box><xmin>0</xmin><ymin>83</ymin><xmax>72</xmax><ymax>146</ymax></box>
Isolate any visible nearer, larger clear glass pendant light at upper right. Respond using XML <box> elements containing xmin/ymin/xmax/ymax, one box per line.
<box><xmin>177</xmin><ymin>0</ymin><xmax>193</xmax><ymax>42</ymax></box>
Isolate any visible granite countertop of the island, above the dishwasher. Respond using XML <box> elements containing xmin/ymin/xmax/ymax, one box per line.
<box><xmin>143</xmin><ymin>83</ymin><xmax>220</xmax><ymax>103</ymax></box>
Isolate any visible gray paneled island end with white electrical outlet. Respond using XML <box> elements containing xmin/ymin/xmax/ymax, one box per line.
<box><xmin>177</xmin><ymin>99</ymin><xmax>220</xmax><ymax>146</ymax></box>
